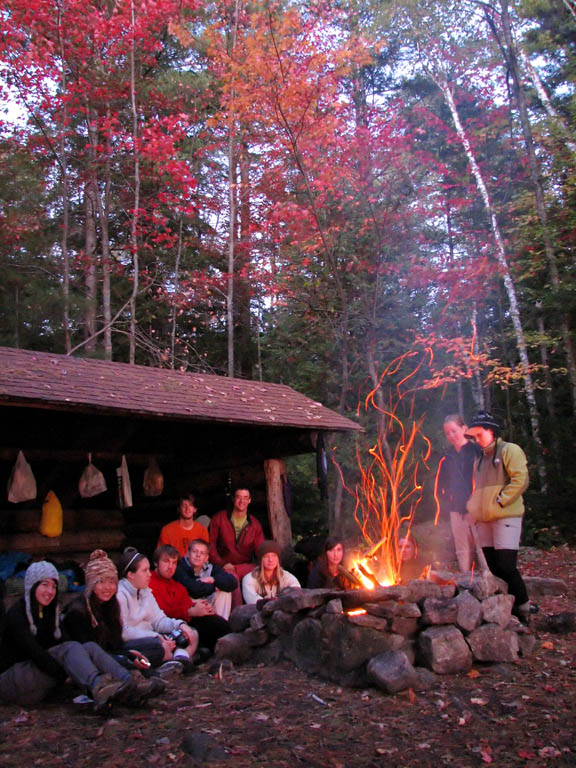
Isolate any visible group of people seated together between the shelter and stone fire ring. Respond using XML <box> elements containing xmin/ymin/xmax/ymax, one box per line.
<box><xmin>0</xmin><ymin>489</ymin><xmax>348</xmax><ymax>711</ymax></box>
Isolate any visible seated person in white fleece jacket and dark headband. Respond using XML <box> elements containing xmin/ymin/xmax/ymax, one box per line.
<box><xmin>118</xmin><ymin>547</ymin><xmax>198</xmax><ymax>675</ymax></box>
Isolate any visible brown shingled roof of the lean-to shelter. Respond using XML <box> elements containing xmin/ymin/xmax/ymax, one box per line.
<box><xmin>0</xmin><ymin>347</ymin><xmax>360</xmax><ymax>431</ymax></box>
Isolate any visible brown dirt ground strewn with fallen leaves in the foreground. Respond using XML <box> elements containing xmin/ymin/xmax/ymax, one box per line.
<box><xmin>0</xmin><ymin>547</ymin><xmax>576</xmax><ymax>768</ymax></box>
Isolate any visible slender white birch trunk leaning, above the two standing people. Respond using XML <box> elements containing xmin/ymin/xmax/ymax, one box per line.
<box><xmin>432</xmin><ymin>74</ymin><xmax>547</xmax><ymax>493</ymax></box>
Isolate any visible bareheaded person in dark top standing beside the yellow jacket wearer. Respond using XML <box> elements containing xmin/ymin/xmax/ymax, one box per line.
<box><xmin>436</xmin><ymin>414</ymin><xmax>482</xmax><ymax>571</ymax></box>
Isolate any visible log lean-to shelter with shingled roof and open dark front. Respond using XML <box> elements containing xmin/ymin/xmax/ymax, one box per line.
<box><xmin>0</xmin><ymin>347</ymin><xmax>359</xmax><ymax>560</ymax></box>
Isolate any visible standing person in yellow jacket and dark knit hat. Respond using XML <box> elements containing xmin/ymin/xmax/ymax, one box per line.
<box><xmin>466</xmin><ymin>411</ymin><xmax>536</xmax><ymax>623</ymax></box>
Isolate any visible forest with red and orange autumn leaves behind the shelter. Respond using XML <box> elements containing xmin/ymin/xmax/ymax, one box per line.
<box><xmin>0</xmin><ymin>0</ymin><xmax>576</xmax><ymax>544</ymax></box>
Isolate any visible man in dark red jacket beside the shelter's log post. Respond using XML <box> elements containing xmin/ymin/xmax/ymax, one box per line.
<box><xmin>209</xmin><ymin>488</ymin><xmax>264</xmax><ymax>607</ymax></box>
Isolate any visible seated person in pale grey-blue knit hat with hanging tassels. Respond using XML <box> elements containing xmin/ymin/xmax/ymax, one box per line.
<box><xmin>0</xmin><ymin>560</ymin><xmax>142</xmax><ymax>712</ymax></box>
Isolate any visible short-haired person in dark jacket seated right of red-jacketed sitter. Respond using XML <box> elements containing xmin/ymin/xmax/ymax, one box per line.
<box><xmin>174</xmin><ymin>539</ymin><xmax>238</xmax><ymax>619</ymax></box>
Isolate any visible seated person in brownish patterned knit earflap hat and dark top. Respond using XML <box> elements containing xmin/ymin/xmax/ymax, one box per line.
<box><xmin>61</xmin><ymin>549</ymin><xmax>165</xmax><ymax>698</ymax></box>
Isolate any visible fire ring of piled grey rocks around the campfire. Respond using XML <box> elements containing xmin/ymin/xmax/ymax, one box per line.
<box><xmin>216</xmin><ymin>572</ymin><xmax>536</xmax><ymax>693</ymax></box>
